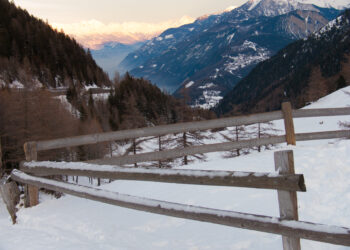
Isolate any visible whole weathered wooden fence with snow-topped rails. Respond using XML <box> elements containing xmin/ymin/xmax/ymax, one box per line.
<box><xmin>2</xmin><ymin>103</ymin><xmax>350</xmax><ymax>249</ymax></box>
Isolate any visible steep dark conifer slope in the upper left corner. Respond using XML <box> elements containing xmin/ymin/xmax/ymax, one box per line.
<box><xmin>0</xmin><ymin>0</ymin><xmax>110</xmax><ymax>88</ymax></box>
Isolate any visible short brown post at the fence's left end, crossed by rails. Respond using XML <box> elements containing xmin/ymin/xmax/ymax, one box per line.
<box><xmin>24</xmin><ymin>142</ymin><xmax>39</xmax><ymax>207</ymax></box>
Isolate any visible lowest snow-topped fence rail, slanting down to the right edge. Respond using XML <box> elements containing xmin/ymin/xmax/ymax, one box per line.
<box><xmin>11</xmin><ymin>170</ymin><xmax>350</xmax><ymax>246</ymax></box>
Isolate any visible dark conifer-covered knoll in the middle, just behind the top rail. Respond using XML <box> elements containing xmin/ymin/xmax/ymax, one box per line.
<box><xmin>67</xmin><ymin>73</ymin><xmax>214</xmax><ymax>131</ymax></box>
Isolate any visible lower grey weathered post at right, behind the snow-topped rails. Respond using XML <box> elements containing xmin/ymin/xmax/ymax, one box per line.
<box><xmin>274</xmin><ymin>150</ymin><xmax>301</xmax><ymax>250</ymax></box>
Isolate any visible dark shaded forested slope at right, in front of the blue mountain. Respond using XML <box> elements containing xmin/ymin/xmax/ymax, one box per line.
<box><xmin>216</xmin><ymin>10</ymin><xmax>350</xmax><ymax>114</ymax></box>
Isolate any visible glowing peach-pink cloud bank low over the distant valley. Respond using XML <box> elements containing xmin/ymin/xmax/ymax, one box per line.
<box><xmin>52</xmin><ymin>16</ymin><xmax>195</xmax><ymax>49</ymax></box>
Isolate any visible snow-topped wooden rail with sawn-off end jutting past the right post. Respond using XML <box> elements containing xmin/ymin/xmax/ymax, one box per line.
<box><xmin>20</xmin><ymin>162</ymin><xmax>306</xmax><ymax>192</ymax></box>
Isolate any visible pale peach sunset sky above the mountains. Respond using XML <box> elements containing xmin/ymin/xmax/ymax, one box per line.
<box><xmin>14</xmin><ymin>0</ymin><xmax>247</xmax><ymax>49</ymax></box>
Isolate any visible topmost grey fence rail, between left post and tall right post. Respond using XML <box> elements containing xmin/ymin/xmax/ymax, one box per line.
<box><xmin>32</xmin><ymin>111</ymin><xmax>283</xmax><ymax>151</ymax></box>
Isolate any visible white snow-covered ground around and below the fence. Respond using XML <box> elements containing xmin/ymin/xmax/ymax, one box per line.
<box><xmin>0</xmin><ymin>87</ymin><xmax>350</xmax><ymax>250</ymax></box>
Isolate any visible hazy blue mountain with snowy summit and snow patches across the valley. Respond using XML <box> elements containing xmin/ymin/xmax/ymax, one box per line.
<box><xmin>120</xmin><ymin>0</ymin><xmax>339</xmax><ymax>108</ymax></box>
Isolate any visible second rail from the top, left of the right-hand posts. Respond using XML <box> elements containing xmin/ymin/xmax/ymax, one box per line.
<box><xmin>87</xmin><ymin>136</ymin><xmax>286</xmax><ymax>166</ymax></box>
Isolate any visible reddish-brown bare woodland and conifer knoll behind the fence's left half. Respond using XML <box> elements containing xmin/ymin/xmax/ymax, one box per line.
<box><xmin>0</xmin><ymin>74</ymin><xmax>215</xmax><ymax>176</ymax></box>
